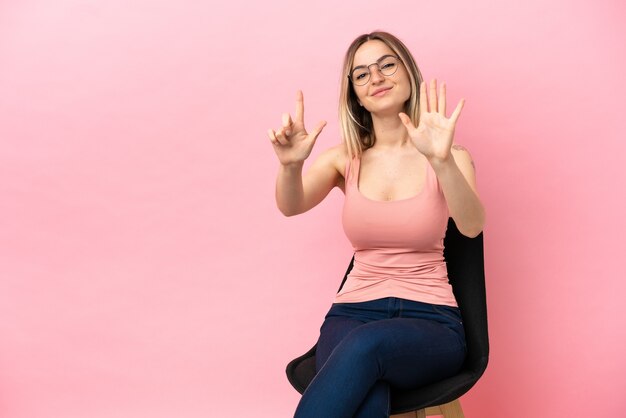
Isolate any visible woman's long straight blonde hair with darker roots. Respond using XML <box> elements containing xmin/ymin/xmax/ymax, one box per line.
<box><xmin>339</xmin><ymin>31</ymin><xmax>422</xmax><ymax>159</ymax></box>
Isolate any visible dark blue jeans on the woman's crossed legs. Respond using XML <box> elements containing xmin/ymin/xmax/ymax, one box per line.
<box><xmin>295</xmin><ymin>297</ymin><xmax>466</xmax><ymax>418</ymax></box>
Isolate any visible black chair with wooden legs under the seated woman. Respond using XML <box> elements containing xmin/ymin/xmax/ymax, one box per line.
<box><xmin>287</xmin><ymin>218</ymin><xmax>489</xmax><ymax>418</ymax></box>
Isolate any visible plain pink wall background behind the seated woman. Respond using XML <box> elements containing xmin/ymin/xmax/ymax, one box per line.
<box><xmin>0</xmin><ymin>0</ymin><xmax>626</xmax><ymax>418</ymax></box>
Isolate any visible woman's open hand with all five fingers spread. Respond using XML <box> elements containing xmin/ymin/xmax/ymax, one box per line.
<box><xmin>399</xmin><ymin>80</ymin><xmax>465</xmax><ymax>162</ymax></box>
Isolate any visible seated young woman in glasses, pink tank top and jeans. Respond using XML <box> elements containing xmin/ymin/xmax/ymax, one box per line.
<box><xmin>268</xmin><ymin>32</ymin><xmax>485</xmax><ymax>418</ymax></box>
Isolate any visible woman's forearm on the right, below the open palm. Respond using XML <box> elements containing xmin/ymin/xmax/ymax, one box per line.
<box><xmin>431</xmin><ymin>158</ymin><xmax>485</xmax><ymax>238</ymax></box>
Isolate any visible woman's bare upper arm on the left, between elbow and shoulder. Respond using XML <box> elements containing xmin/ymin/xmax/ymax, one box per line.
<box><xmin>302</xmin><ymin>144</ymin><xmax>345</xmax><ymax>212</ymax></box>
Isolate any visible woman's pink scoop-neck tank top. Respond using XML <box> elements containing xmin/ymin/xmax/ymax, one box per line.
<box><xmin>335</xmin><ymin>158</ymin><xmax>457</xmax><ymax>307</ymax></box>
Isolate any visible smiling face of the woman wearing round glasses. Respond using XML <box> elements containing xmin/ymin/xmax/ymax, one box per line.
<box><xmin>351</xmin><ymin>39</ymin><xmax>411</xmax><ymax>116</ymax></box>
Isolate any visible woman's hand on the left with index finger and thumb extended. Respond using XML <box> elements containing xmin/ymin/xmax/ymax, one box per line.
<box><xmin>267</xmin><ymin>91</ymin><xmax>326</xmax><ymax>166</ymax></box>
